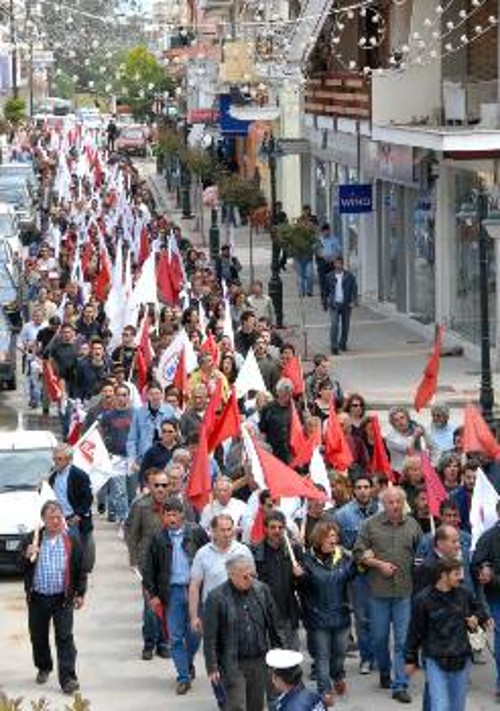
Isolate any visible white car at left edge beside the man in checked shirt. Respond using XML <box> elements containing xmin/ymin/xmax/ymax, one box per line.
<box><xmin>0</xmin><ymin>429</ymin><xmax>57</xmax><ymax>573</ymax></box>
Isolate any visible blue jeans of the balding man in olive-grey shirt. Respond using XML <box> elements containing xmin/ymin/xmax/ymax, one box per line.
<box><xmin>370</xmin><ymin>597</ymin><xmax>410</xmax><ymax>691</ymax></box>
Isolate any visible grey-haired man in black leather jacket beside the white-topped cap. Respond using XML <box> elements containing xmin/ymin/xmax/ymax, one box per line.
<box><xmin>203</xmin><ymin>555</ymin><xmax>283</xmax><ymax>711</ymax></box>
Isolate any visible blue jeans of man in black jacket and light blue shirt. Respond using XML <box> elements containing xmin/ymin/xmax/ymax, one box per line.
<box><xmin>167</xmin><ymin>585</ymin><xmax>200</xmax><ymax>683</ymax></box>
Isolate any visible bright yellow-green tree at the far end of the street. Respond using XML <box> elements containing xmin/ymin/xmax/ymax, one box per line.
<box><xmin>117</xmin><ymin>45</ymin><xmax>175</xmax><ymax>119</ymax></box>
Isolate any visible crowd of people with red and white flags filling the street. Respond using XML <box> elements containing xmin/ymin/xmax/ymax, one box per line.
<box><xmin>11</xmin><ymin>118</ymin><xmax>500</xmax><ymax>711</ymax></box>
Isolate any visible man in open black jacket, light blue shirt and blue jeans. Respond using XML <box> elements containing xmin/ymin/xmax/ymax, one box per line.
<box><xmin>142</xmin><ymin>497</ymin><xmax>208</xmax><ymax>695</ymax></box>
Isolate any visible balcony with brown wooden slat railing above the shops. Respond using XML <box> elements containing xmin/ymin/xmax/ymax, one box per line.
<box><xmin>304</xmin><ymin>72</ymin><xmax>371</xmax><ymax>120</ymax></box>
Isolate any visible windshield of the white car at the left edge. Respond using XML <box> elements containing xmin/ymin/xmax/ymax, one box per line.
<box><xmin>0</xmin><ymin>449</ymin><xmax>53</xmax><ymax>492</ymax></box>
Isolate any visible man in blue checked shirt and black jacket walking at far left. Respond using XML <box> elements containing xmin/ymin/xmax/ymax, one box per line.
<box><xmin>22</xmin><ymin>501</ymin><xmax>87</xmax><ymax>694</ymax></box>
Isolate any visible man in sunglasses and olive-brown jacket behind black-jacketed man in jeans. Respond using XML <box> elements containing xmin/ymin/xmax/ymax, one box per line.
<box><xmin>125</xmin><ymin>469</ymin><xmax>169</xmax><ymax>661</ymax></box>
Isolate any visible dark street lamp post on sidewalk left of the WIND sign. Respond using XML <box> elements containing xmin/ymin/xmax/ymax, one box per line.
<box><xmin>260</xmin><ymin>131</ymin><xmax>283</xmax><ymax>328</ymax></box>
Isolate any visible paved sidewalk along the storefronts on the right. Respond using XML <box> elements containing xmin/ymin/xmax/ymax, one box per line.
<box><xmin>149</xmin><ymin>165</ymin><xmax>498</xmax><ymax>418</ymax></box>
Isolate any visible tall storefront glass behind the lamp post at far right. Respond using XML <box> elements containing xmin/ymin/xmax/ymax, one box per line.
<box><xmin>451</xmin><ymin>171</ymin><xmax>496</xmax><ymax>343</ymax></box>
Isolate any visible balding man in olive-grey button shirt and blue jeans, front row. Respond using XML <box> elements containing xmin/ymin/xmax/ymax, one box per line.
<box><xmin>353</xmin><ymin>486</ymin><xmax>422</xmax><ymax>703</ymax></box>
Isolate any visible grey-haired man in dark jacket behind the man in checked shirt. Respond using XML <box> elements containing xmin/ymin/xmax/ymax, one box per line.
<box><xmin>49</xmin><ymin>444</ymin><xmax>95</xmax><ymax>573</ymax></box>
